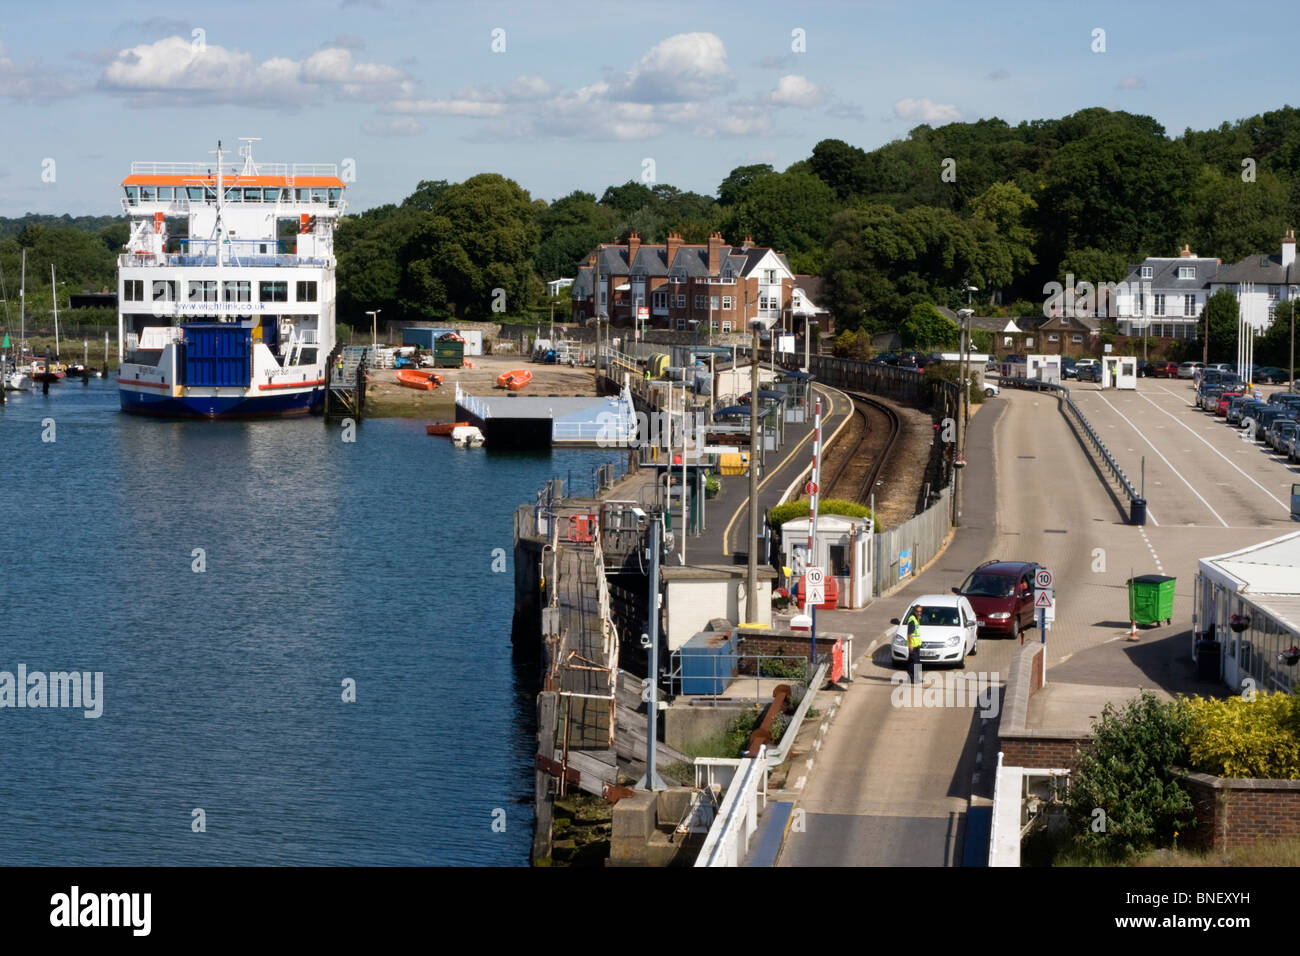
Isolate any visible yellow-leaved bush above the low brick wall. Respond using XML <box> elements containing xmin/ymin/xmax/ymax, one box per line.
<box><xmin>1183</xmin><ymin>693</ymin><xmax>1300</xmax><ymax>780</ymax></box>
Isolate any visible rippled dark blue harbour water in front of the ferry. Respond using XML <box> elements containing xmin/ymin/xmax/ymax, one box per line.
<box><xmin>0</xmin><ymin>380</ymin><xmax>618</xmax><ymax>865</ymax></box>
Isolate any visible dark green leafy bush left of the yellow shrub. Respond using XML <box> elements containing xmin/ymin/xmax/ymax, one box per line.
<box><xmin>1069</xmin><ymin>691</ymin><xmax>1195</xmax><ymax>858</ymax></box>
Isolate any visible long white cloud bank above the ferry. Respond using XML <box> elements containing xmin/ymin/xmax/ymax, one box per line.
<box><xmin>99</xmin><ymin>36</ymin><xmax>410</xmax><ymax>107</ymax></box>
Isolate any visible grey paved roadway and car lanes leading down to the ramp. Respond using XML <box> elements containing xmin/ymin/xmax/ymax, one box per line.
<box><xmin>779</xmin><ymin>382</ymin><xmax>1295</xmax><ymax>866</ymax></box>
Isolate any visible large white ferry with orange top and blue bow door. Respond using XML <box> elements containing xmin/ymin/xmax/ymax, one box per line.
<box><xmin>117</xmin><ymin>137</ymin><xmax>346</xmax><ymax>419</ymax></box>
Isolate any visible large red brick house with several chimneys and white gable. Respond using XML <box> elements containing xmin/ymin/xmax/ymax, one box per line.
<box><xmin>572</xmin><ymin>233</ymin><xmax>828</xmax><ymax>332</ymax></box>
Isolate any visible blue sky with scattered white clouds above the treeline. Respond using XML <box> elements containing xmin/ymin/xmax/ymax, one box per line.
<box><xmin>0</xmin><ymin>0</ymin><xmax>1300</xmax><ymax>216</ymax></box>
